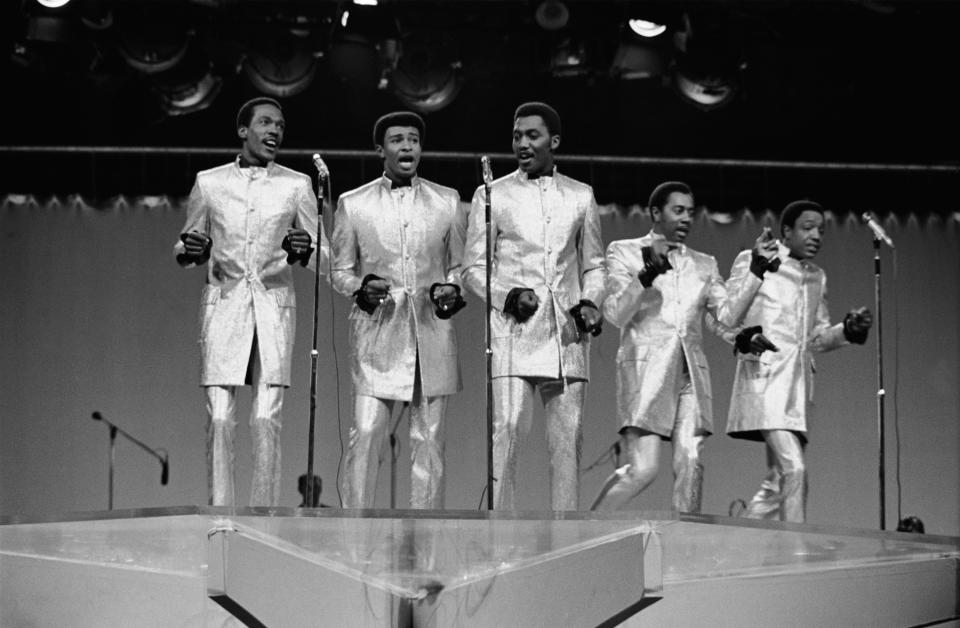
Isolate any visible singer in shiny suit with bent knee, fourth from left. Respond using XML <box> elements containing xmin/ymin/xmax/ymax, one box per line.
<box><xmin>593</xmin><ymin>181</ymin><xmax>773</xmax><ymax>513</ymax></box>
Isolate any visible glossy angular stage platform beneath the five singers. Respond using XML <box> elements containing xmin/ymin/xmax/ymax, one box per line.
<box><xmin>0</xmin><ymin>507</ymin><xmax>960</xmax><ymax>628</ymax></box>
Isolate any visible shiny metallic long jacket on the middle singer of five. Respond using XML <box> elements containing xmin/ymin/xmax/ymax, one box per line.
<box><xmin>463</xmin><ymin>170</ymin><xmax>604</xmax><ymax>379</ymax></box>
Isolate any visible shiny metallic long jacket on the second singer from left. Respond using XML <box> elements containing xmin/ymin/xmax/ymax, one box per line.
<box><xmin>331</xmin><ymin>176</ymin><xmax>466</xmax><ymax>400</ymax></box>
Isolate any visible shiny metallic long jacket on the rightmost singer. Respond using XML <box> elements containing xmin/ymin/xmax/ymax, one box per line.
<box><xmin>727</xmin><ymin>245</ymin><xmax>849</xmax><ymax>440</ymax></box>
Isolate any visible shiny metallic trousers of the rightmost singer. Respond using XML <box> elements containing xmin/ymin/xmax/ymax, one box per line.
<box><xmin>743</xmin><ymin>430</ymin><xmax>807</xmax><ymax>523</ymax></box>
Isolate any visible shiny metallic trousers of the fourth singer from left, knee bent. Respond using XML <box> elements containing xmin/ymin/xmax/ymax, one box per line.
<box><xmin>590</xmin><ymin>383</ymin><xmax>706</xmax><ymax>513</ymax></box>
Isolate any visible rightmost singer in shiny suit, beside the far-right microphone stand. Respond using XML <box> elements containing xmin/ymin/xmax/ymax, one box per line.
<box><xmin>727</xmin><ymin>201</ymin><xmax>873</xmax><ymax>522</ymax></box>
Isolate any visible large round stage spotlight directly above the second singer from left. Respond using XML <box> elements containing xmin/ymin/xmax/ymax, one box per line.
<box><xmin>391</xmin><ymin>33</ymin><xmax>461</xmax><ymax>113</ymax></box>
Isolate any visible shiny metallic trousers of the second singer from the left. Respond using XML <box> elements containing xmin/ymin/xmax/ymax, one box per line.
<box><xmin>341</xmin><ymin>386</ymin><xmax>448</xmax><ymax>509</ymax></box>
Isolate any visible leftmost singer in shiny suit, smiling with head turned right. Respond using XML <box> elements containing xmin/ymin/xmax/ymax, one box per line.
<box><xmin>174</xmin><ymin>98</ymin><xmax>329</xmax><ymax>506</ymax></box>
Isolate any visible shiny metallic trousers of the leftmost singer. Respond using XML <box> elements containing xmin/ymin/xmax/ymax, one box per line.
<box><xmin>206</xmin><ymin>384</ymin><xmax>284</xmax><ymax>506</ymax></box>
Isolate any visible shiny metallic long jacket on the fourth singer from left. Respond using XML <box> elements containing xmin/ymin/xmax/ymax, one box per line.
<box><xmin>603</xmin><ymin>232</ymin><xmax>760</xmax><ymax>436</ymax></box>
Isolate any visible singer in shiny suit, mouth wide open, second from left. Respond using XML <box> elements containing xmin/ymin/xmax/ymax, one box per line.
<box><xmin>331</xmin><ymin>111</ymin><xmax>466</xmax><ymax>508</ymax></box>
